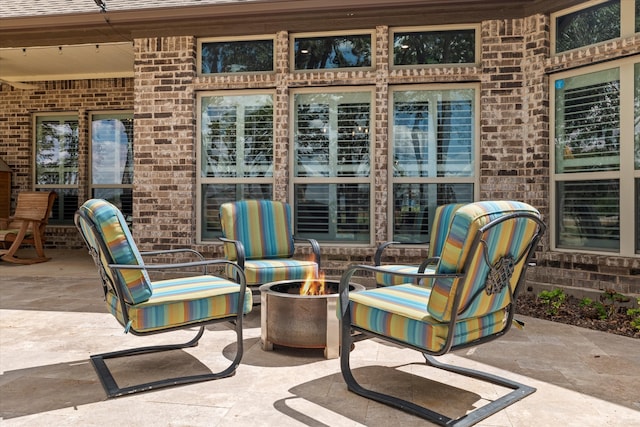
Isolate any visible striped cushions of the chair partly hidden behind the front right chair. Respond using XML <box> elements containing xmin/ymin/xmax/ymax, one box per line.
<box><xmin>376</xmin><ymin>203</ymin><xmax>464</xmax><ymax>286</ymax></box>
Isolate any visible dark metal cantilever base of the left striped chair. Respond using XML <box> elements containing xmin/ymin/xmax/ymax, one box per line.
<box><xmin>90</xmin><ymin>326</ymin><xmax>242</xmax><ymax>398</ymax></box>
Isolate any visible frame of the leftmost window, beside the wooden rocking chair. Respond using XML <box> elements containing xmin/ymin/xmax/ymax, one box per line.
<box><xmin>31</xmin><ymin>111</ymin><xmax>79</xmax><ymax>226</ymax></box>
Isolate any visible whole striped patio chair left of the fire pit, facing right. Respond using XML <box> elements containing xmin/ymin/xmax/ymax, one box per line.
<box><xmin>75</xmin><ymin>199</ymin><xmax>252</xmax><ymax>397</ymax></box>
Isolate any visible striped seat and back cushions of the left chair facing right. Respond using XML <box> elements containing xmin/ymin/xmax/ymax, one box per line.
<box><xmin>79</xmin><ymin>199</ymin><xmax>252</xmax><ymax>332</ymax></box>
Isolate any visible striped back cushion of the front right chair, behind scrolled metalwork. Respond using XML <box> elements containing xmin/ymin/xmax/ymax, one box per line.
<box><xmin>427</xmin><ymin>201</ymin><xmax>540</xmax><ymax>322</ymax></box>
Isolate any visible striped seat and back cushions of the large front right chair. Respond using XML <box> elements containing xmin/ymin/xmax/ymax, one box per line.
<box><xmin>349</xmin><ymin>201</ymin><xmax>540</xmax><ymax>352</ymax></box>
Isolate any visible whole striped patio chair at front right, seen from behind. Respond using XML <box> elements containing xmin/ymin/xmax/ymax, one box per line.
<box><xmin>339</xmin><ymin>201</ymin><xmax>545</xmax><ymax>426</ymax></box>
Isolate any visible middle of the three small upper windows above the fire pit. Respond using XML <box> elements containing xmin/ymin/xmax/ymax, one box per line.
<box><xmin>292</xmin><ymin>33</ymin><xmax>374</xmax><ymax>70</ymax></box>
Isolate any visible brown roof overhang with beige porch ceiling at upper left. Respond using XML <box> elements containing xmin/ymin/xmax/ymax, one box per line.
<box><xmin>0</xmin><ymin>0</ymin><xmax>581</xmax><ymax>87</ymax></box>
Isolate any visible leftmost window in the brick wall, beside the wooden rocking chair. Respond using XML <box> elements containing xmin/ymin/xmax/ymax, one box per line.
<box><xmin>34</xmin><ymin>114</ymin><xmax>79</xmax><ymax>224</ymax></box>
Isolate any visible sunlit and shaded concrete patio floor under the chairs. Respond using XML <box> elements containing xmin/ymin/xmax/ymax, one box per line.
<box><xmin>0</xmin><ymin>250</ymin><xmax>640</xmax><ymax>427</ymax></box>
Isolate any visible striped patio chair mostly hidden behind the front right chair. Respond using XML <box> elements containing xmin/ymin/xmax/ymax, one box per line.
<box><xmin>373</xmin><ymin>203</ymin><xmax>464</xmax><ymax>287</ymax></box>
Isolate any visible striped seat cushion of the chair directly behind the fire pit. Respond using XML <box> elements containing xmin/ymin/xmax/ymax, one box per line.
<box><xmin>226</xmin><ymin>259</ymin><xmax>318</xmax><ymax>285</ymax></box>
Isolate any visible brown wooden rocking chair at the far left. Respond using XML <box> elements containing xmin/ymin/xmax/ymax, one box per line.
<box><xmin>0</xmin><ymin>191</ymin><xmax>57</xmax><ymax>264</ymax></box>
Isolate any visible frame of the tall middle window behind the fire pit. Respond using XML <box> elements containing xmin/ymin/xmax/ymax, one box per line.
<box><xmin>288</xmin><ymin>85</ymin><xmax>376</xmax><ymax>247</ymax></box>
